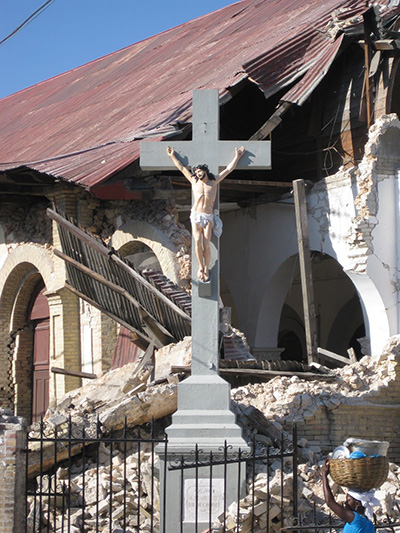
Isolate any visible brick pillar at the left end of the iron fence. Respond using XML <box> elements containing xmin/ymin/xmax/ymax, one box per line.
<box><xmin>0</xmin><ymin>409</ymin><xmax>27</xmax><ymax>533</ymax></box>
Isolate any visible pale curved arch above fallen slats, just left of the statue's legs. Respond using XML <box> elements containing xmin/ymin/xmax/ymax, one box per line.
<box><xmin>111</xmin><ymin>220</ymin><xmax>180</xmax><ymax>284</ymax></box>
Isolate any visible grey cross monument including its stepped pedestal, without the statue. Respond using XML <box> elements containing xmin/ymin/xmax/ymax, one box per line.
<box><xmin>140</xmin><ymin>90</ymin><xmax>271</xmax><ymax>533</ymax></box>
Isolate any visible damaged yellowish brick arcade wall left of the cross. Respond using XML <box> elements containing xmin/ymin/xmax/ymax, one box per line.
<box><xmin>0</xmin><ymin>184</ymin><xmax>190</xmax><ymax>420</ymax></box>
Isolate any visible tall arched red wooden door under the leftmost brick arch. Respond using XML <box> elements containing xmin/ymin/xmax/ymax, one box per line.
<box><xmin>30</xmin><ymin>287</ymin><xmax>50</xmax><ymax>422</ymax></box>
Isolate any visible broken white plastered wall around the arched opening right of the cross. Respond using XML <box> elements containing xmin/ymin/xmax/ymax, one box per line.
<box><xmin>221</xmin><ymin>115</ymin><xmax>400</xmax><ymax>360</ymax></box>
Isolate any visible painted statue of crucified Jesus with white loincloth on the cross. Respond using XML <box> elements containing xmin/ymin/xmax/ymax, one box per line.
<box><xmin>167</xmin><ymin>141</ymin><xmax>246</xmax><ymax>282</ymax></box>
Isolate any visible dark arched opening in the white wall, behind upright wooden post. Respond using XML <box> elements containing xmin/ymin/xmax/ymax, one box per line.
<box><xmin>278</xmin><ymin>252</ymin><xmax>365</xmax><ymax>361</ymax></box>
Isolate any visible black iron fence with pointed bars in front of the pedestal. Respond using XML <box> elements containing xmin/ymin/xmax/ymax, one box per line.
<box><xmin>26</xmin><ymin>420</ymin><xmax>298</xmax><ymax>533</ymax></box>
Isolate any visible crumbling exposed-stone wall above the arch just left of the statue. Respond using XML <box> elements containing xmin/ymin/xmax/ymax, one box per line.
<box><xmin>87</xmin><ymin>200</ymin><xmax>191</xmax><ymax>280</ymax></box>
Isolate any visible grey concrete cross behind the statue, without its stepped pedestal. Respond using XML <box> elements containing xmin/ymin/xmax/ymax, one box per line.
<box><xmin>140</xmin><ymin>90</ymin><xmax>271</xmax><ymax>376</ymax></box>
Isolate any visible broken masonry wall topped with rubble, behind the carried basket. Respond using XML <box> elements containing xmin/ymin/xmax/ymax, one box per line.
<box><xmin>232</xmin><ymin>336</ymin><xmax>400</xmax><ymax>463</ymax></box>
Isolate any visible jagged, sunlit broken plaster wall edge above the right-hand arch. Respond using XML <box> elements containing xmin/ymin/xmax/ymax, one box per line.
<box><xmin>308</xmin><ymin>114</ymin><xmax>400</xmax><ymax>273</ymax></box>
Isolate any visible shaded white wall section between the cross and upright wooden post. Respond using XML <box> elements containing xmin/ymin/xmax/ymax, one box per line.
<box><xmin>221</xmin><ymin>203</ymin><xmax>297</xmax><ymax>347</ymax></box>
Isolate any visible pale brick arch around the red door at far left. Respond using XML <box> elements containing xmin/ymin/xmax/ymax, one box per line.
<box><xmin>0</xmin><ymin>244</ymin><xmax>54</xmax><ymax>420</ymax></box>
